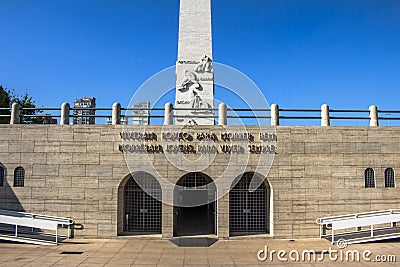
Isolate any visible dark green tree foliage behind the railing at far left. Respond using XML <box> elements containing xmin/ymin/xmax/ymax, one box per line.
<box><xmin>0</xmin><ymin>85</ymin><xmax>43</xmax><ymax>124</ymax></box>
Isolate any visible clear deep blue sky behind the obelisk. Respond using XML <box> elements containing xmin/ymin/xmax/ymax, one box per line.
<box><xmin>0</xmin><ymin>0</ymin><xmax>400</xmax><ymax>124</ymax></box>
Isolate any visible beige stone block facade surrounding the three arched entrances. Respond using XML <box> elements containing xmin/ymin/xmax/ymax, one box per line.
<box><xmin>0</xmin><ymin>125</ymin><xmax>400</xmax><ymax>238</ymax></box>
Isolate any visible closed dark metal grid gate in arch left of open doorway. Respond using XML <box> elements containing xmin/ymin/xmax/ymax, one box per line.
<box><xmin>124</xmin><ymin>173</ymin><xmax>161</xmax><ymax>233</ymax></box>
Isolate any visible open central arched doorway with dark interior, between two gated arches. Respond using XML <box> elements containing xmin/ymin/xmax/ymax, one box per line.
<box><xmin>174</xmin><ymin>172</ymin><xmax>217</xmax><ymax>237</ymax></box>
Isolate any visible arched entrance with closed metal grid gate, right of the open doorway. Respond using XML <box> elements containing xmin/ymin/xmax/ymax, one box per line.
<box><xmin>229</xmin><ymin>172</ymin><xmax>271</xmax><ymax>236</ymax></box>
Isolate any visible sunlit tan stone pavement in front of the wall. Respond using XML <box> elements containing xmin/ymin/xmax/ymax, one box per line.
<box><xmin>0</xmin><ymin>238</ymin><xmax>400</xmax><ymax>267</ymax></box>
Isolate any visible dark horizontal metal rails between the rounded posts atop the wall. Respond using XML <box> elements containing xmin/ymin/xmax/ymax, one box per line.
<box><xmin>0</xmin><ymin>104</ymin><xmax>400</xmax><ymax>126</ymax></box>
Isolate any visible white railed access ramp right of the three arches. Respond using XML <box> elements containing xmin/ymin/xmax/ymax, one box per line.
<box><xmin>316</xmin><ymin>209</ymin><xmax>400</xmax><ymax>244</ymax></box>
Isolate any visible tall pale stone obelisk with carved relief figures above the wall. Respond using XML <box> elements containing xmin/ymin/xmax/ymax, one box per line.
<box><xmin>175</xmin><ymin>0</ymin><xmax>214</xmax><ymax>125</ymax></box>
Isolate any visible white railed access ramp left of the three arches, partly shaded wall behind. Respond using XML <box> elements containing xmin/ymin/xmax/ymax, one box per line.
<box><xmin>0</xmin><ymin>210</ymin><xmax>74</xmax><ymax>245</ymax></box>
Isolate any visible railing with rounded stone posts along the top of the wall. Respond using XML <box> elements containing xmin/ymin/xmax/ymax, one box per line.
<box><xmin>0</xmin><ymin>104</ymin><xmax>400</xmax><ymax>126</ymax></box>
